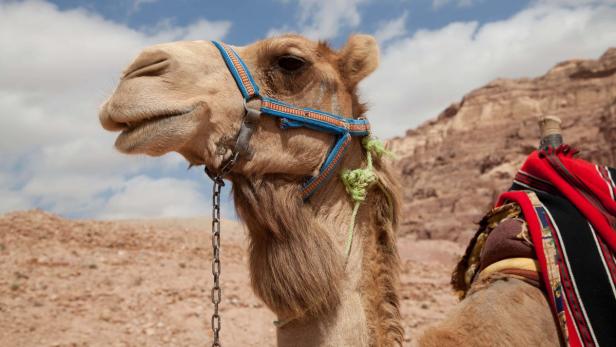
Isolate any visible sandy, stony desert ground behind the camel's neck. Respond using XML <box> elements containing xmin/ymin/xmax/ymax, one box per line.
<box><xmin>0</xmin><ymin>210</ymin><xmax>462</xmax><ymax>347</ymax></box>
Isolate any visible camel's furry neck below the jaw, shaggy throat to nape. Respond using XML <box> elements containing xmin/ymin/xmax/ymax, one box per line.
<box><xmin>233</xmin><ymin>142</ymin><xmax>403</xmax><ymax>346</ymax></box>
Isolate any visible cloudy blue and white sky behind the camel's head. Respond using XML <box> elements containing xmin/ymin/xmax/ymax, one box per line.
<box><xmin>0</xmin><ymin>0</ymin><xmax>616</xmax><ymax>219</ymax></box>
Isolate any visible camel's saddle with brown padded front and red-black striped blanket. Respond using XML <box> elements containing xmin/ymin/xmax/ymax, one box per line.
<box><xmin>452</xmin><ymin>145</ymin><xmax>616</xmax><ymax>346</ymax></box>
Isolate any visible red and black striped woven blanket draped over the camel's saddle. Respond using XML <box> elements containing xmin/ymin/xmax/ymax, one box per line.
<box><xmin>497</xmin><ymin>145</ymin><xmax>616</xmax><ymax>346</ymax></box>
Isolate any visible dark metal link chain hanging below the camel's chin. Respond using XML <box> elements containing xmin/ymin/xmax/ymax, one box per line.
<box><xmin>205</xmin><ymin>153</ymin><xmax>238</xmax><ymax>347</ymax></box>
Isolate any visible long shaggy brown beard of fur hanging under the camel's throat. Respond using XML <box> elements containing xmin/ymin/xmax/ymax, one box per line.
<box><xmin>233</xmin><ymin>176</ymin><xmax>343</xmax><ymax>317</ymax></box>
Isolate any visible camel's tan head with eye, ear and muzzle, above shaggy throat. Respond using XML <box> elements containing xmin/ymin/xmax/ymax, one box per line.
<box><xmin>99</xmin><ymin>35</ymin><xmax>378</xmax><ymax>177</ymax></box>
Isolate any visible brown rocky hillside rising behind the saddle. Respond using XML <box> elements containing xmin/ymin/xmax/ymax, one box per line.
<box><xmin>390</xmin><ymin>48</ymin><xmax>616</xmax><ymax>242</ymax></box>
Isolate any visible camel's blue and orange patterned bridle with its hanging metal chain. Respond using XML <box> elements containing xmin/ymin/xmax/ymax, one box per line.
<box><xmin>205</xmin><ymin>41</ymin><xmax>370</xmax><ymax>346</ymax></box>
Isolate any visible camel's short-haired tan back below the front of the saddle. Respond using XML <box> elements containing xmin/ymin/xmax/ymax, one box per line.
<box><xmin>419</xmin><ymin>275</ymin><xmax>560</xmax><ymax>347</ymax></box>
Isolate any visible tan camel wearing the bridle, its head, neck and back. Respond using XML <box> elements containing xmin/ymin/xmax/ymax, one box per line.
<box><xmin>99</xmin><ymin>35</ymin><xmax>559</xmax><ymax>346</ymax></box>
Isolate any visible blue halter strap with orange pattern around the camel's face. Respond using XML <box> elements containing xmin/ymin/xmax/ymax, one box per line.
<box><xmin>212</xmin><ymin>41</ymin><xmax>370</xmax><ymax>201</ymax></box>
